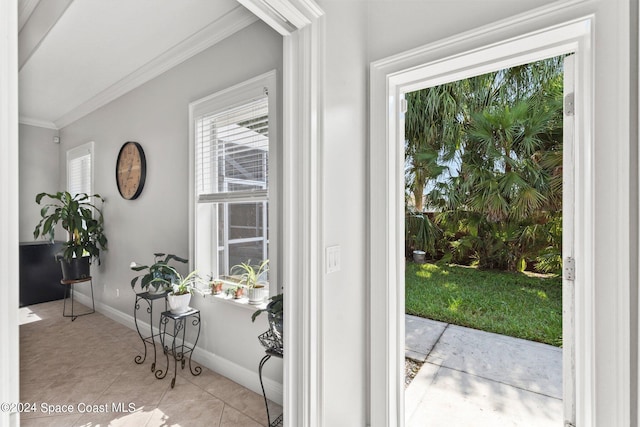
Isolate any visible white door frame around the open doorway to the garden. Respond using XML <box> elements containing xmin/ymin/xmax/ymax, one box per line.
<box><xmin>369</xmin><ymin>10</ymin><xmax>595</xmax><ymax>427</ymax></box>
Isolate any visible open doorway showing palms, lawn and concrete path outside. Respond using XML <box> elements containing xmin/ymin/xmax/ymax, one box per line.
<box><xmin>400</xmin><ymin>56</ymin><xmax>575</xmax><ymax>426</ymax></box>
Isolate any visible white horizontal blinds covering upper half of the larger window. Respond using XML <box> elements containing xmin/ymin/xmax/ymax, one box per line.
<box><xmin>195</xmin><ymin>95</ymin><xmax>269</xmax><ymax>202</ymax></box>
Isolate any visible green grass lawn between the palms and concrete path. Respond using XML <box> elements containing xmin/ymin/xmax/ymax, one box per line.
<box><xmin>405</xmin><ymin>262</ymin><xmax>562</xmax><ymax>347</ymax></box>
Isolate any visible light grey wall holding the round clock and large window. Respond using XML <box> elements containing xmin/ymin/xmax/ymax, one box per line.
<box><xmin>59</xmin><ymin>22</ymin><xmax>283</xmax><ymax>400</ymax></box>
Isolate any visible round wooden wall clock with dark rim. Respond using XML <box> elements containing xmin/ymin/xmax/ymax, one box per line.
<box><xmin>116</xmin><ymin>141</ymin><xmax>147</xmax><ymax>200</ymax></box>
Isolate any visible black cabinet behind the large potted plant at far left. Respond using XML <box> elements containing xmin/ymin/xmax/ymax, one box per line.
<box><xmin>20</xmin><ymin>242</ymin><xmax>64</xmax><ymax>307</ymax></box>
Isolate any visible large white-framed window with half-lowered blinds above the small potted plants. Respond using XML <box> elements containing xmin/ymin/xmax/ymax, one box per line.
<box><xmin>190</xmin><ymin>72</ymin><xmax>277</xmax><ymax>279</ymax></box>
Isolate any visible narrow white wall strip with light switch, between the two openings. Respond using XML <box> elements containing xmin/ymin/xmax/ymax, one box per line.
<box><xmin>322</xmin><ymin>2</ymin><xmax>367</xmax><ymax>426</ymax></box>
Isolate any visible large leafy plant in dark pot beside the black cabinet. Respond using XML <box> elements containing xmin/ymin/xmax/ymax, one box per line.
<box><xmin>33</xmin><ymin>191</ymin><xmax>107</xmax><ymax>280</ymax></box>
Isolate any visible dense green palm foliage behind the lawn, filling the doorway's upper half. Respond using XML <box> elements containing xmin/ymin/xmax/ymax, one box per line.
<box><xmin>405</xmin><ymin>57</ymin><xmax>562</xmax><ymax>270</ymax></box>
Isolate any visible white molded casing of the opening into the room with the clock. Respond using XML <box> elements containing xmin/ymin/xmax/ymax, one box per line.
<box><xmin>238</xmin><ymin>0</ymin><xmax>324</xmax><ymax>427</ymax></box>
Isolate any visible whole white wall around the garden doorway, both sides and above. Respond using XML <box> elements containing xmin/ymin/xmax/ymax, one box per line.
<box><xmin>319</xmin><ymin>0</ymin><xmax>638</xmax><ymax>426</ymax></box>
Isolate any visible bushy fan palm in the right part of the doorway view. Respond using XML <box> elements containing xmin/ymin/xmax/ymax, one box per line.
<box><xmin>451</xmin><ymin>65</ymin><xmax>562</xmax><ymax>270</ymax></box>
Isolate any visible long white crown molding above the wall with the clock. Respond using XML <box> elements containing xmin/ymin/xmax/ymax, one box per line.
<box><xmin>54</xmin><ymin>6</ymin><xmax>258</xmax><ymax>129</ymax></box>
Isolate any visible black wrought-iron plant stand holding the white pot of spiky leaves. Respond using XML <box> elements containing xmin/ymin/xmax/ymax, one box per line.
<box><xmin>155</xmin><ymin>308</ymin><xmax>202</xmax><ymax>388</ymax></box>
